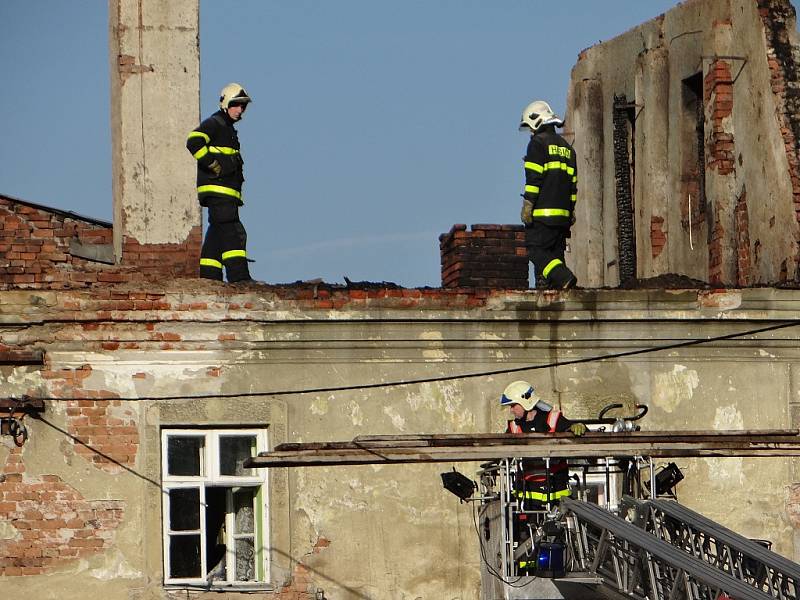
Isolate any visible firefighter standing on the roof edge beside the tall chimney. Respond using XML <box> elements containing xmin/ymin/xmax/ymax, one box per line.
<box><xmin>186</xmin><ymin>83</ymin><xmax>252</xmax><ymax>283</ymax></box>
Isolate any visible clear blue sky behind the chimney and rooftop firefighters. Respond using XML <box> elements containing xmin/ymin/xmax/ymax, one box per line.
<box><xmin>0</xmin><ymin>0</ymin><xmax>792</xmax><ymax>286</ymax></box>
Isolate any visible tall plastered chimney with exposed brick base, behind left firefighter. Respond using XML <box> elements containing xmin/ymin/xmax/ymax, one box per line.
<box><xmin>109</xmin><ymin>0</ymin><xmax>202</xmax><ymax>276</ymax></box>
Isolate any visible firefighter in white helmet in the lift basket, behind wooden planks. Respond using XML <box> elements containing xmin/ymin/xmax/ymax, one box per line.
<box><xmin>500</xmin><ymin>381</ymin><xmax>586</xmax><ymax>510</ymax></box>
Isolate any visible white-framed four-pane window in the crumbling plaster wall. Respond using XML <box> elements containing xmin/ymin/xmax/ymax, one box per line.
<box><xmin>161</xmin><ymin>429</ymin><xmax>269</xmax><ymax>587</ymax></box>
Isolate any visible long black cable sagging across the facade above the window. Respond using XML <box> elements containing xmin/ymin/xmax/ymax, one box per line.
<box><xmin>12</xmin><ymin>321</ymin><xmax>800</xmax><ymax>402</ymax></box>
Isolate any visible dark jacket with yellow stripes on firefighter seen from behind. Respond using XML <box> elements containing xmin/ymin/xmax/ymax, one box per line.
<box><xmin>522</xmin><ymin>126</ymin><xmax>578</xmax><ymax>228</ymax></box>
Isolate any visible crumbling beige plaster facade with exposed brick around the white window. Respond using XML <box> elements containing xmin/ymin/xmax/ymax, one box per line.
<box><xmin>0</xmin><ymin>280</ymin><xmax>800</xmax><ymax>600</ymax></box>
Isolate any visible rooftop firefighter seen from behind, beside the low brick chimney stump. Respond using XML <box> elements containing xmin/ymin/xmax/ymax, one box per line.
<box><xmin>519</xmin><ymin>100</ymin><xmax>578</xmax><ymax>290</ymax></box>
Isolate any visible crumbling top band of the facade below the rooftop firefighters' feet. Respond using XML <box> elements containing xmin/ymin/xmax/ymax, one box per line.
<box><xmin>0</xmin><ymin>280</ymin><xmax>800</xmax><ymax>325</ymax></box>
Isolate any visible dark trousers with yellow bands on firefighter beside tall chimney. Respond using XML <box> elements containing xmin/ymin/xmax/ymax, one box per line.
<box><xmin>200</xmin><ymin>198</ymin><xmax>250</xmax><ymax>283</ymax></box>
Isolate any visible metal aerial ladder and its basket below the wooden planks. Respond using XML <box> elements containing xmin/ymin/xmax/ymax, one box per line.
<box><xmin>477</xmin><ymin>458</ymin><xmax>800</xmax><ymax>600</ymax></box>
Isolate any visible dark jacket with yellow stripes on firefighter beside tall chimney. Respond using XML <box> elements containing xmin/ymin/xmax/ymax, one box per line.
<box><xmin>186</xmin><ymin>110</ymin><xmax>244</xmax><ymax>206</ymax></box>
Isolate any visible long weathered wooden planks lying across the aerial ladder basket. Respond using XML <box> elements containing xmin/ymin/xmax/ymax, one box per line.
<box><xmin>245</xmin><ymin>430</ymin><xmax>800</xmax><ymax>468</ymax></box>
